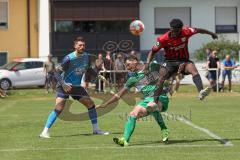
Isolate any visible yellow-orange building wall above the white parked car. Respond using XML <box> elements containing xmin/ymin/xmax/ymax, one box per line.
<box><xmin>0</xmin><ymin>0</ymin><xmax>38</xmax><ymax>62</ymax></box>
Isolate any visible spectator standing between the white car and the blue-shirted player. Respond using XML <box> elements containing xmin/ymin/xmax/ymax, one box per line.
<box><xmin>43</xmin><ymin>54</ymin><xmax>56</xmax><ymax>93</ymax></box>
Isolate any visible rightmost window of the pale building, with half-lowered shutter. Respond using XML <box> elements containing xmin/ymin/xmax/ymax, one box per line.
<box><xmin>215</xmin><ymin>7</ymin><xmax>237</xmax><ymax>33</ymax></box>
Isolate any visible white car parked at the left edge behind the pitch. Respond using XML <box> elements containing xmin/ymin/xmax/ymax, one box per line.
<box><xmin>0</xmin><ymin>58</ymin><xmax>46</xmax><ymax>90</ymax></box>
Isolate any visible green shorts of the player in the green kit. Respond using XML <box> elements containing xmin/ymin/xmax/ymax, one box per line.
<box><xmin>138</xmin><ymin>95</ymin><xmax>169</xmax><ymax>112</ymax></box>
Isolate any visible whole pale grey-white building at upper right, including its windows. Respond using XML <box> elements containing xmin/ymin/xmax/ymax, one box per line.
<box><xmin>139</xmin><ymin>0</ymin><xmax>240</xmax><ymax>56</ymax></box>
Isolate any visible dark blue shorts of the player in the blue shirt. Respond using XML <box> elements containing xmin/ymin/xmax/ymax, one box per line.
<box><xmin>56</xmin><ymin>86</ymin><xmax>89</xmax><ymax>101</ymax></box>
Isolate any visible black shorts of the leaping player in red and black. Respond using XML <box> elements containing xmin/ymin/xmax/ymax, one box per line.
<box><xmin>161</xmin><ymin>60</ymin><xmax>193</xmax><ymax>79</ymax></box>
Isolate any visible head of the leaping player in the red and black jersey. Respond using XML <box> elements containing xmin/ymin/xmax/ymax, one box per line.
<box><xmin>169</xmin><ymin>18</ymin><xmax>183</xmax><ymax>37</ymax></box>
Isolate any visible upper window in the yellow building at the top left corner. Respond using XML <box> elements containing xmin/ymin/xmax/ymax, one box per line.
<box><xmin>0</xmin><ymin>0</ymin><xmax>8</xmax><ymax>28</ymax></box>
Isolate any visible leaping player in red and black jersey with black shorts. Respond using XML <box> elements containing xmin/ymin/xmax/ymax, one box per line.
<box><xmin>145</xmin><ymin>19</ymin><xmax>218</xmax><ymax>103</ymax></box>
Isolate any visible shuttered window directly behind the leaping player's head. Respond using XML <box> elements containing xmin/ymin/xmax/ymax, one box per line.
<box><xmin>154</xmin><ymin>7</ymin><xmax>191</xmax><ymax>34</ymax></box>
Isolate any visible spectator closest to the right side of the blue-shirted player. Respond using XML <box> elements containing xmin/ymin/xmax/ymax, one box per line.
<box><xmin>95</xmin><ymin>53</ymin><xmax>106</xmax><ymax>92</ymax></box>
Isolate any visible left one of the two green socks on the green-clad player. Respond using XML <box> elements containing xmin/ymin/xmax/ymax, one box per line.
<box><xmin>123</xmin><ymin>116</ymin><xmax>137</xmax><ymax>142</ymax></box>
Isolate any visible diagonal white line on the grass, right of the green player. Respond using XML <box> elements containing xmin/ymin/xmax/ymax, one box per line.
<box><xmin>162</xmin><ymin>113</ymin><xmax>233</xmax><ymax>146</ymax></box>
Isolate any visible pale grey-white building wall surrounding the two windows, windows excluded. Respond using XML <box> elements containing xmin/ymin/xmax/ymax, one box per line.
<box><xmin>140</xmin><ymin>0</ymin><xmax>240</xmax><ymax>56</ymax></box>
